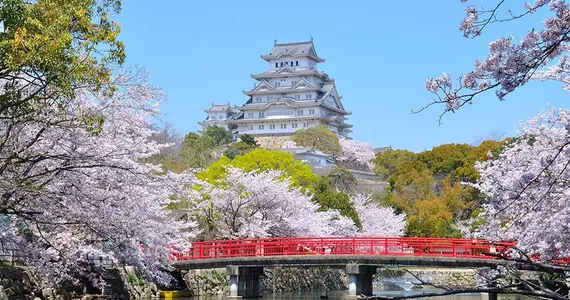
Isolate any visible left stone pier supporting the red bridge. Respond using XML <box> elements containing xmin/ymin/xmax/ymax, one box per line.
<box><xmin>226</xmin><ymin>265</ymin><xmax>263</xmax><ymax>299</ymax></box>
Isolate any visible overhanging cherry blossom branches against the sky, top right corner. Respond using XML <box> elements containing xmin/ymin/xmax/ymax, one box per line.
<box><xmin>422</xmin><ymin>0</ymin><xmax>570</xmax><ymax>116</ymax></box>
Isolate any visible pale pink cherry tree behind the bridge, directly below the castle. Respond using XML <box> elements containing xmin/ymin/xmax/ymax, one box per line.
<box><xmin>197</xmin><ymin>167</ymin><xmax>356</xmax><ymax>239</ymax></box>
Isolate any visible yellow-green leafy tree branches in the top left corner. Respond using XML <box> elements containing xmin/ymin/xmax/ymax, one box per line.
<box><xmin>0</xmin><ymin>0</ymin><xmax>125</xmax><ymax>114</ymax></box>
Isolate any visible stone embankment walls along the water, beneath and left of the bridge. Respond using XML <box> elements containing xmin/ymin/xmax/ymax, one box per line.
<box><xmin>0</xmin><ymin>267</ymin><xmax>477</xmax><ymax>300</ymax></box>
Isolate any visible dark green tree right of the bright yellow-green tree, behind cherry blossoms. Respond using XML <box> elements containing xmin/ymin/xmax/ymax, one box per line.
<box><xmin>313</xmin><ymin>176</ymin><xmax>362</xmax><ymax>228</ymax></box>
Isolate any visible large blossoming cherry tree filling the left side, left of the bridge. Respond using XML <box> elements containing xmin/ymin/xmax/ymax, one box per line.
<box><xmin>0</xmin><ymin>71</ymin><xmax>194</xmax><ymax>283</ymax></box>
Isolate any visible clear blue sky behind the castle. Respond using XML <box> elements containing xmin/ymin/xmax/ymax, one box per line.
<box><xmin>116</xmin><ymin>0</ymin><xmax>568</xmax><ymax>151</ymax></box>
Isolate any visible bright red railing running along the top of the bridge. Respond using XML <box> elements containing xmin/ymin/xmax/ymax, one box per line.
<box><xmin>172</xmin><ymin>237</ymin><xmax>514</xmax><ymax>260</ymax></box>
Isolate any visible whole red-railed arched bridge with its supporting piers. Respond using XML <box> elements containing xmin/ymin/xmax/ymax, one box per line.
<box><xmin>173</xmin><ymin>237</ymin><xmax>514</xmax><ymax>296</ymax></box>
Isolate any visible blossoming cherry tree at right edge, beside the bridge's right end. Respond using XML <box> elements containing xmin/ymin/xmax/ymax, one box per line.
<box><xmin>476</xmin><ymin>109</ymin><xmax>570</xmax><ymax>261</ymax></box>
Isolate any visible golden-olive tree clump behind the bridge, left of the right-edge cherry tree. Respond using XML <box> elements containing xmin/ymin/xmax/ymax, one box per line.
<box><xmin>375</xmin><ymin>141</ymin><xmax>503</xmax><ymax>237</ymax></box>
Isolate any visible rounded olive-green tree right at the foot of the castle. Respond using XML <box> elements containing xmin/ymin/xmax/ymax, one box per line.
<box><xmin>291</xmin><ymin>125</ymin><xmax>342</xmax><ymax>156</ymax></box>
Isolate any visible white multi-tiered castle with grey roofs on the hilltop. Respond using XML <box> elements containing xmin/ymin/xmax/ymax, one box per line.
<box><xmin>199</xmin><ymin>38</ymin><xmax>352</xmax><ymax>136</ymax></box>
